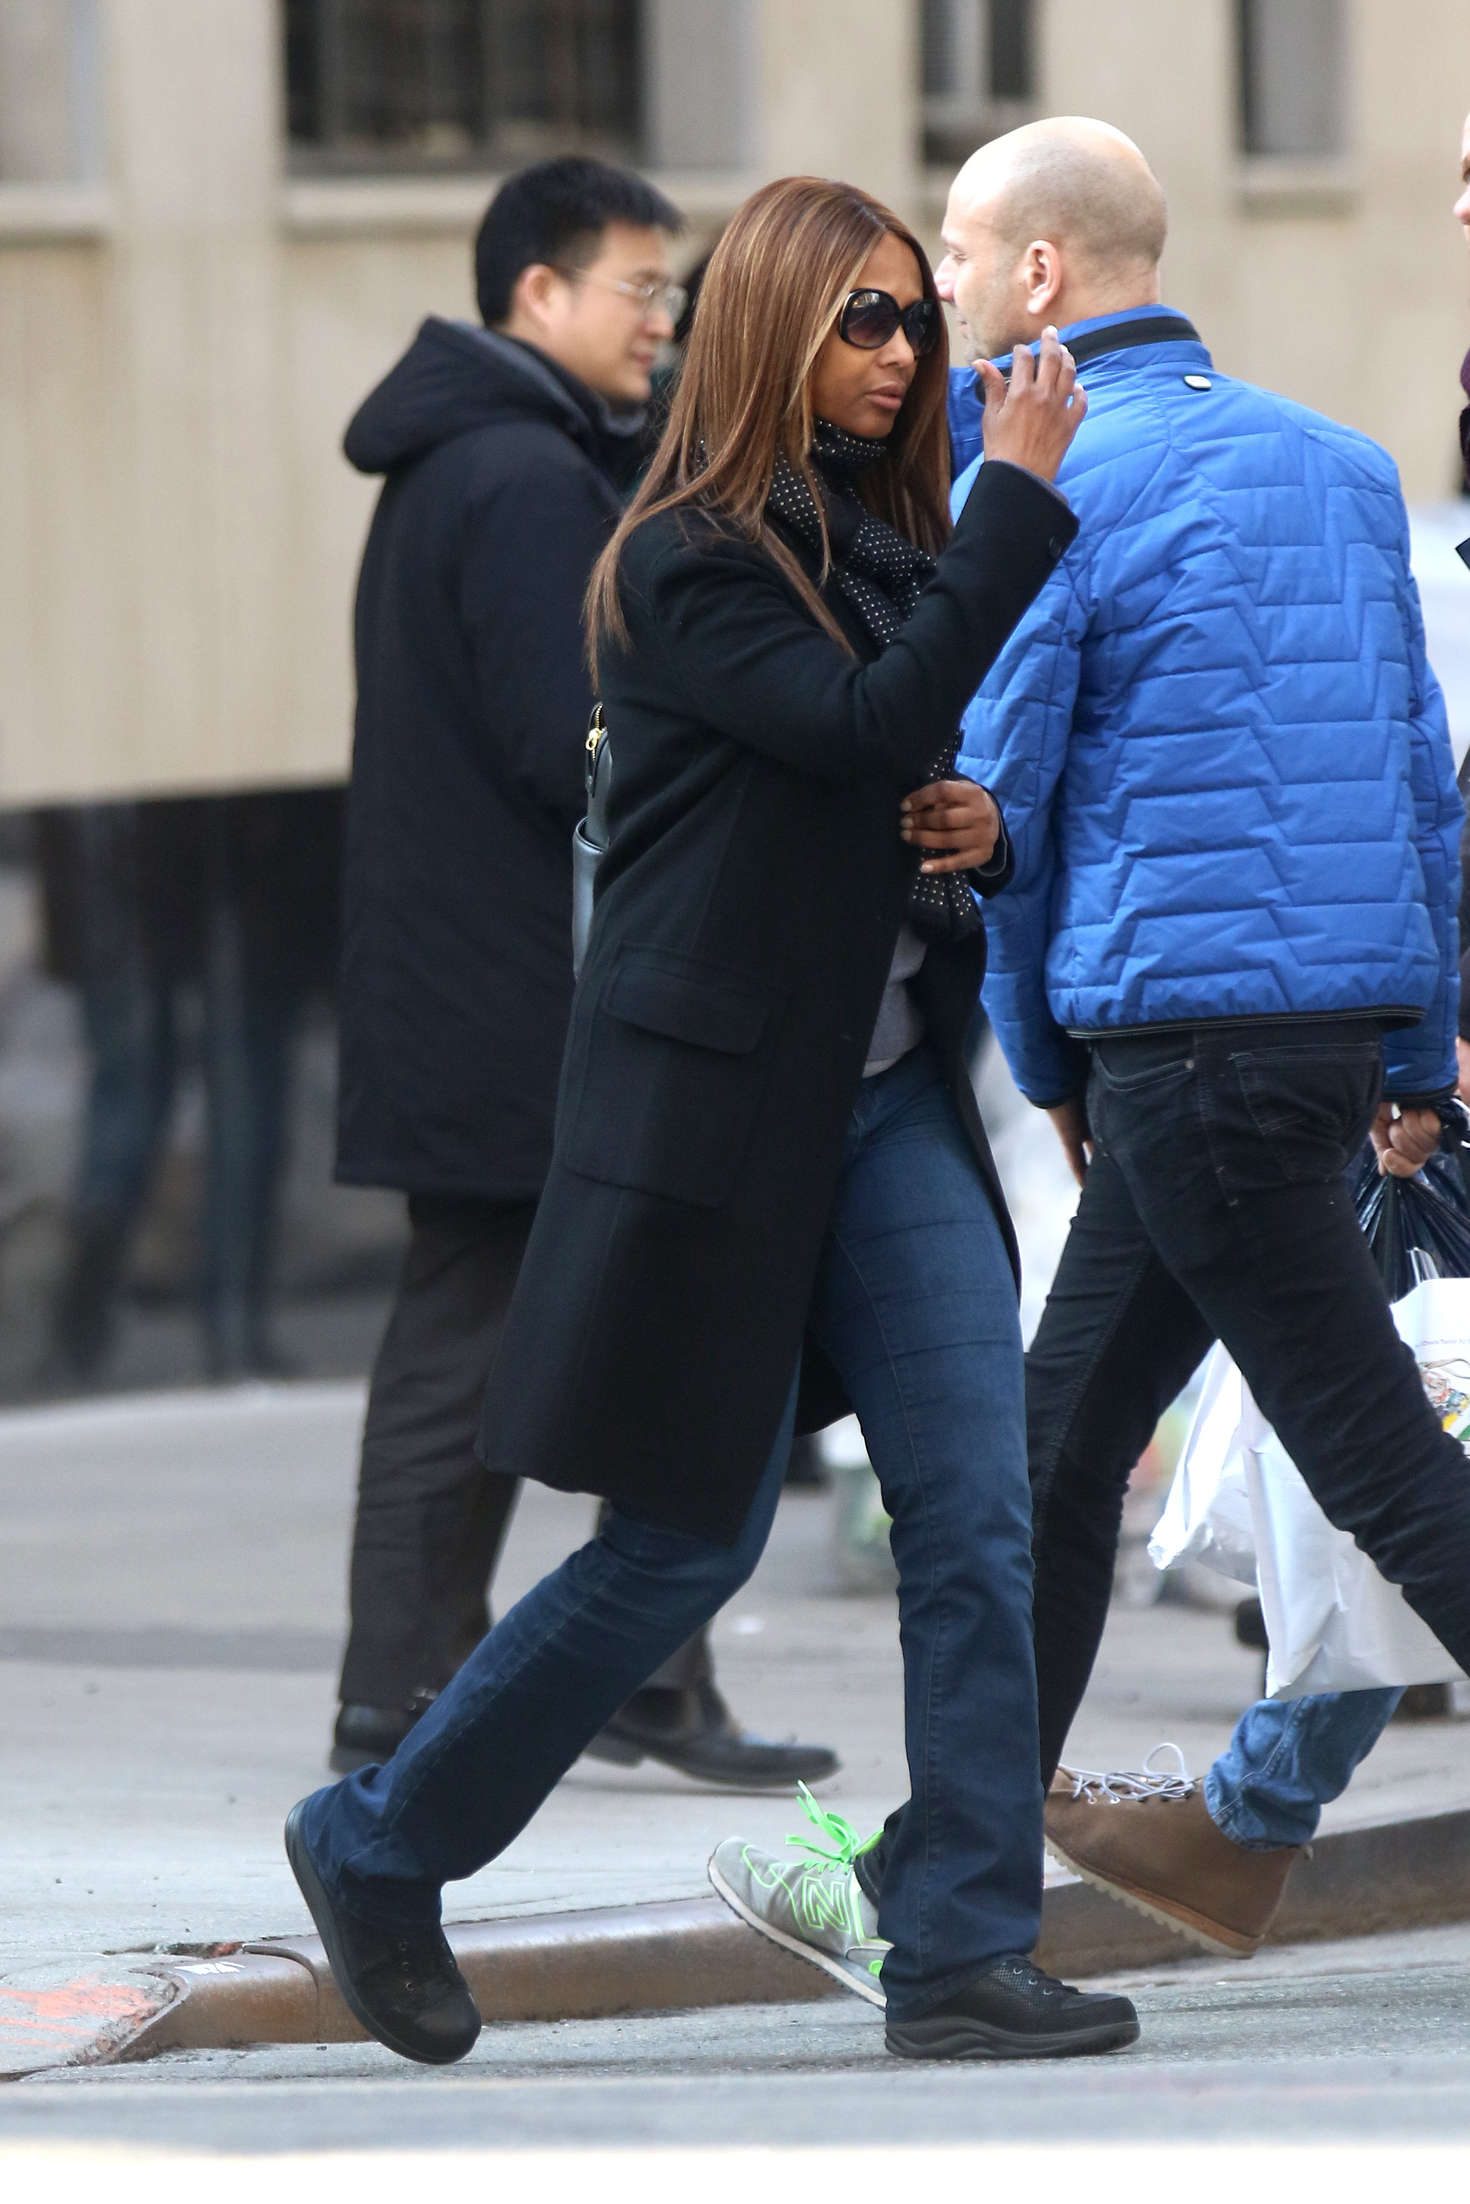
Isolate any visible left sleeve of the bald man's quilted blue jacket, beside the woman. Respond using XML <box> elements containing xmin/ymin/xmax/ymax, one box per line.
<box><xmin>954</xmin><ymin>465</ymin><xmax>1087</xmax><ymax>1106</ymax></box>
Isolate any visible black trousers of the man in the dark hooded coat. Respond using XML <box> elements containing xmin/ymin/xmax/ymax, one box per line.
<box><xmin>342</xmin><ymin>1195</ymin><xmax>712</xmax><ymax>1706</ymax></box>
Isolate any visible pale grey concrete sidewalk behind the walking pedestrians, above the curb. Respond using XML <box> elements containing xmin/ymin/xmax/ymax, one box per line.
<box><xmin>0</xmin><ymin>1386</ymin><xmax>1470</xmax><ymax>2056</ymax></box>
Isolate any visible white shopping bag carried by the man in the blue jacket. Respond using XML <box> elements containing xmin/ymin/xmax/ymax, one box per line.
<box><xmin>1148</xmin><ymin>1278</ymin><xmax>1470</xmax><ymax>1699</ymax></box>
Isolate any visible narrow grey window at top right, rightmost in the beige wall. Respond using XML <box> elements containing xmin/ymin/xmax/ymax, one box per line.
<box><xmin>1236</xmin><ymin>0</ymin><xmax>1347</xmax><ymax>161</ymax></box>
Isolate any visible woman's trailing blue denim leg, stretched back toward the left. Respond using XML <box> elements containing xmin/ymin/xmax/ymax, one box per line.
<box><xmin>304</xmin><ymin>1389</ymin><xmax>796</xmax><ymax>1924</ymax></box>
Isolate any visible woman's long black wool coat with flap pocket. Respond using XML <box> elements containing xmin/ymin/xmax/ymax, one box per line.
<box><xmin>483</xmin><ymin>463</ymin><xmax>1076</xmax><ymax>1543</ymax></box>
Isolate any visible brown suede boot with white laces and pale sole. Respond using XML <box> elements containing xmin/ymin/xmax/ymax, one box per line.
<box><xmin>1045</xmin><ymin>1768</ymin><xmax>1307</xmax><ymax>1959</ymax></box>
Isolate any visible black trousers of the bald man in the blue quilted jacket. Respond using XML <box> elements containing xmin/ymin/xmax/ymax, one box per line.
<box><xmin>860</xmin><ymin>1020</ymin><xmax>1470</xmax><ymax>1887</ymax></box>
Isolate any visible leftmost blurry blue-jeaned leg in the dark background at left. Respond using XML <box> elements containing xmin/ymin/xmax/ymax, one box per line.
<box><xmin>48</xmin><ymin>804</ymin><xmax>176</xmax><ymax>1382</ymax></box>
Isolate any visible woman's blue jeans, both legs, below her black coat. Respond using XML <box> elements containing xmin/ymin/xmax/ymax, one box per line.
<box><xmin>304</xmin><ymin>1049</ymin><xmax>1042</xmax><ymax>2017</ymax></box>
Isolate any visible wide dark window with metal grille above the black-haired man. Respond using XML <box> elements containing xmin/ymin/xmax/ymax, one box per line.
<box><xmin>284</xmin><ymin>0</ymin><xmax>641</xmax><ymax>172</ymax></box>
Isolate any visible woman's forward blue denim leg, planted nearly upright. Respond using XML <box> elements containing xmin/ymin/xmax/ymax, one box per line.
<box><xmin>813</xmin><ymin>1049</ymin><xmax>1042</xmax><ymax>2017</ymax></box>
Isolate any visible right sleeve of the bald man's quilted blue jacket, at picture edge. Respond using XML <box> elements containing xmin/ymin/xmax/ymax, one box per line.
<box><xmin>1384</xmin><ymin>516</ymin><xmax>1463</xmax><ymax>1095</ymax></box>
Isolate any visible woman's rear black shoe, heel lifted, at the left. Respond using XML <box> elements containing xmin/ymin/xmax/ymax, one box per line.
<box><xmin>287</xmin><ymin>1798</ymin><xmax>480</xmax><ymax>2065</ymax></box>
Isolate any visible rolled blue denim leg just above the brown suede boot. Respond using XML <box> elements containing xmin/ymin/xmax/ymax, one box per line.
<box><xmin>1206</xmin><ymin>1690</ymin><xmax>1402</xmax><ymax>1851</ymax></box>
